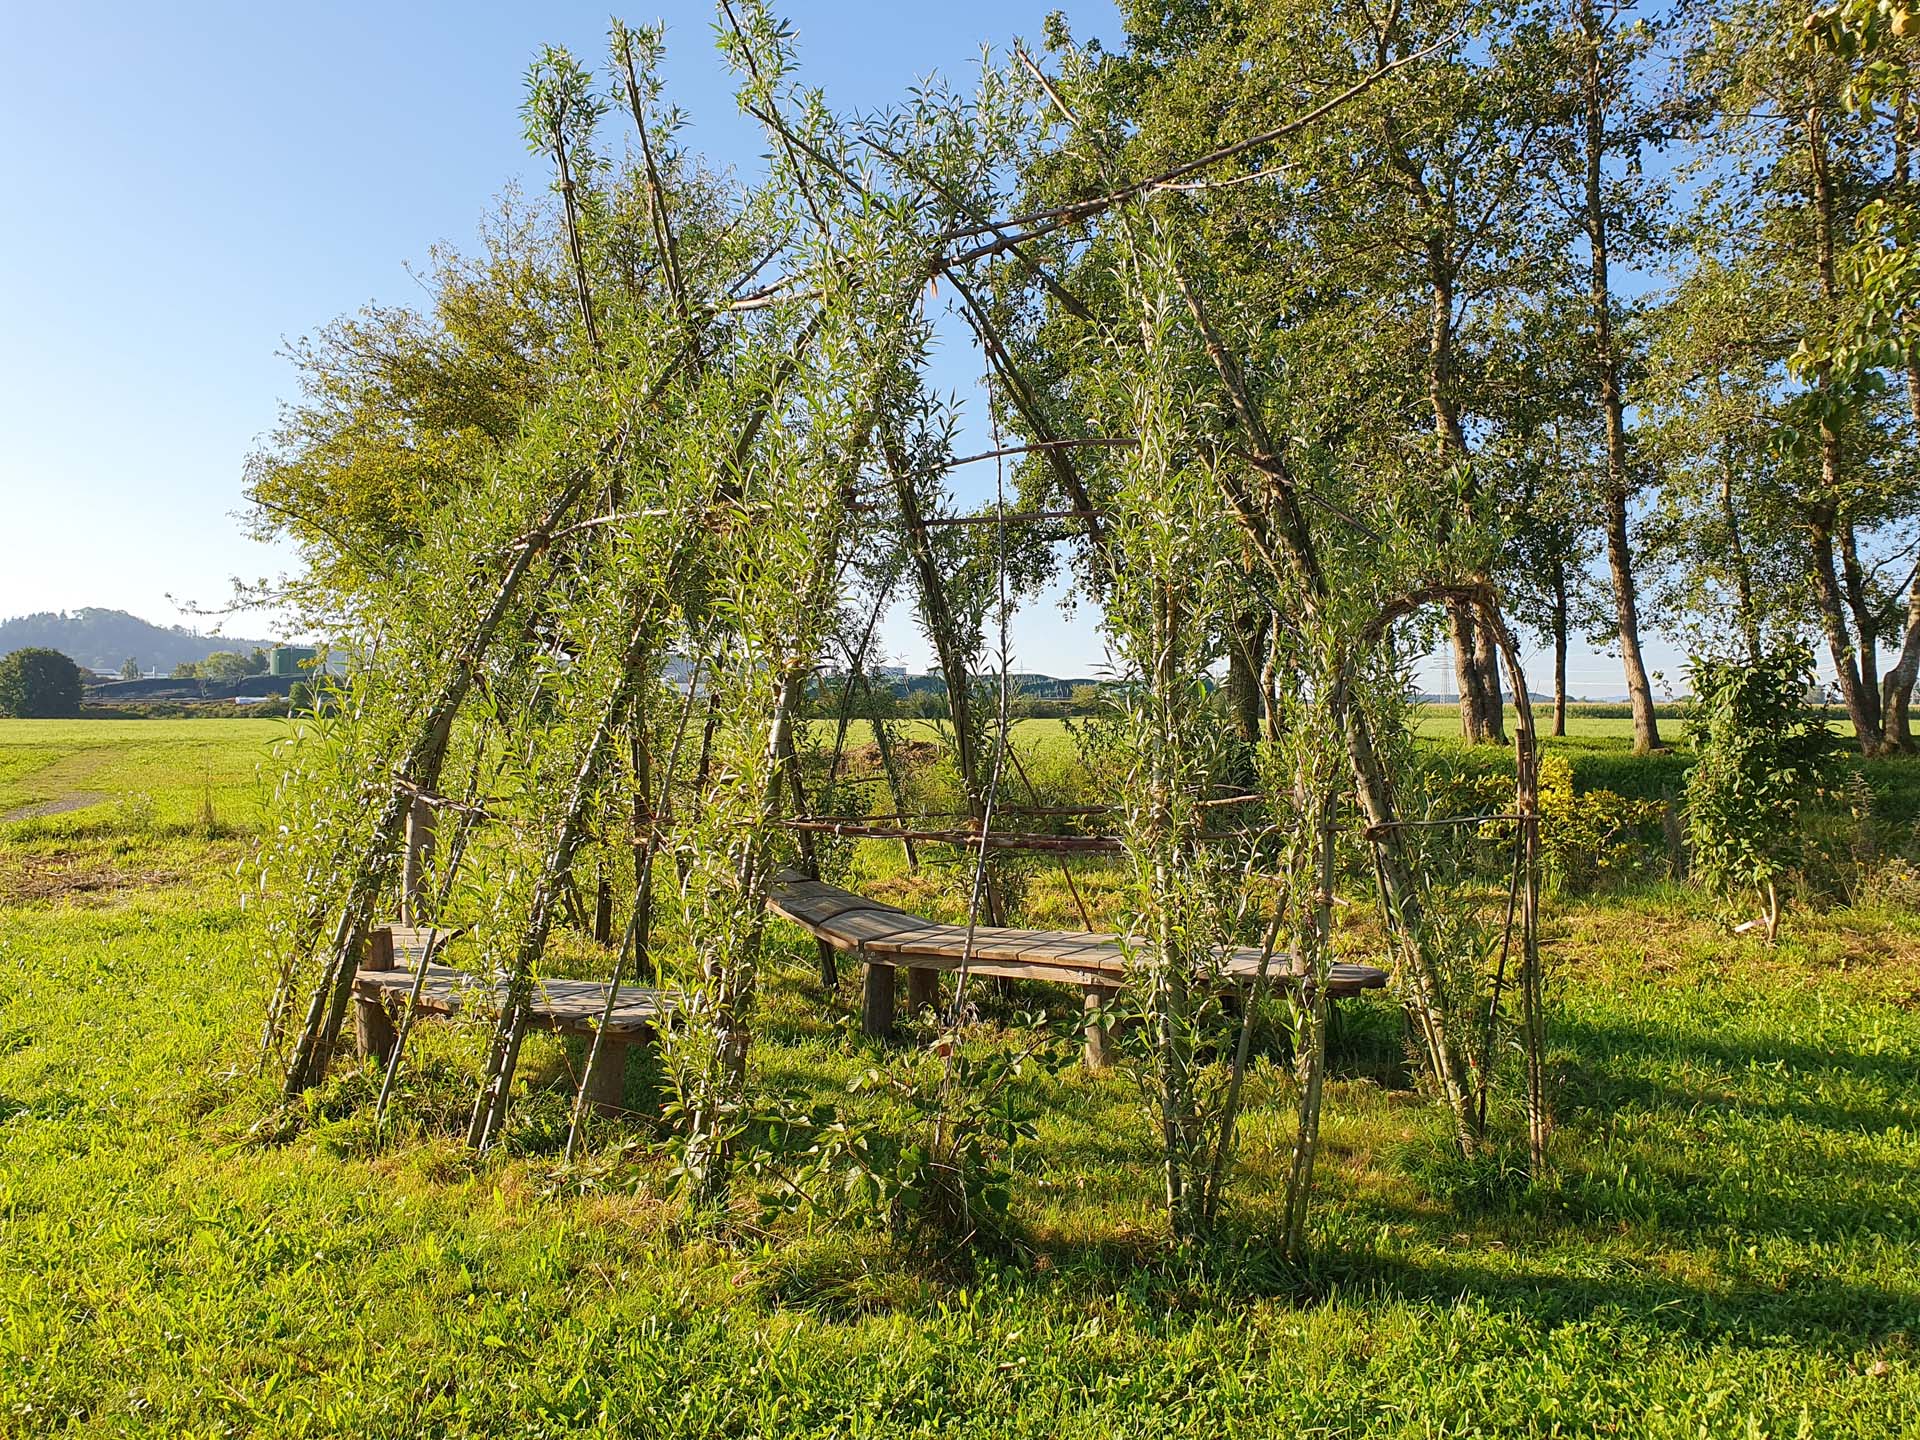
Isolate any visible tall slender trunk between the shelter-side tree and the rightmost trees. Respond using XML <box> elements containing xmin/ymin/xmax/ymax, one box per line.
<box><xmin>1580</xmin><ymin>0</ymin><xmax>1661</xmax><ymax>755</ymax></box>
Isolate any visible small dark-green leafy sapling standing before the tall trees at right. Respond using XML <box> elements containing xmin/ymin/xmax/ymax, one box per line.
<box><xmin>1686</xmin><ymin>647</ymin><xmax>1837</xmax><ymax>941</ymax></box>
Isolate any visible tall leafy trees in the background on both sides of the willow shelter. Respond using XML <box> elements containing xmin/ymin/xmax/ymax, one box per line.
<box><xmin>250</xmin><ymin>0</ymin><xmax>1920</xmax><ymax>753</ymax></box>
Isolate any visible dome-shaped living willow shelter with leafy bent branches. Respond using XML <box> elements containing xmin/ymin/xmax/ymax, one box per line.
<box><xmin>263</xmin><ymin>0</ymin><xmax>1546</xmax><ymax>1248</ymax></box>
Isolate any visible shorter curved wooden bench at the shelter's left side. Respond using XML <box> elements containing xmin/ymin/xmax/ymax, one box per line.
<box><xmin>353</xmin><ymin>925</ymin><xmax>672</xmax><ymax>1112</ymax></box>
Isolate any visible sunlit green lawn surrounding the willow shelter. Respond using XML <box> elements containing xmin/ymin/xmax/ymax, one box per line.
<box><xmin>0</xmin><ymin>722</ymin><xmax>1920</xmax><ymax>1440</ymax></box>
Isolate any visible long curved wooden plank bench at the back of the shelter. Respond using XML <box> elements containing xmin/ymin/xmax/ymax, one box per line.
<box><xmin>770</xmin><ymin>870</ymin><xmax>1386</xmax><ymax>1068</ymax></box>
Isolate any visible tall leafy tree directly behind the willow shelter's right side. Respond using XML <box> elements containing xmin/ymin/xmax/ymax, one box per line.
<box><xmin>1041</xmin><ymin>0</ymin><xmax>1551</xmax><ymax>741</ymax></box>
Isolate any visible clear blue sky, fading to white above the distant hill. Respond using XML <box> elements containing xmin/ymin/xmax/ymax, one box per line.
<box><xmin>0</xmin><ymin>0</ymin><xmax>1672</xmax><ymax>693</ymax></box>
